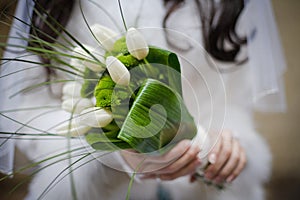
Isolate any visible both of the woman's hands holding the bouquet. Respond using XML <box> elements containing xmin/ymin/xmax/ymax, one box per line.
<box><xmin>122</xmin><ymin>131</ymin><xmax>247</xmax><ymax>183</ymax></box>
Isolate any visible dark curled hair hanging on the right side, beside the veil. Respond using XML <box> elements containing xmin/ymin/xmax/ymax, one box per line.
<box><xmin>163</xmin><ymin>0</ymin><xmax>247</xmax><ymax>62</ymax></box>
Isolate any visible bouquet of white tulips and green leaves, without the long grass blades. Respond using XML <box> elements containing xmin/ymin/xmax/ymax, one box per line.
<box><xmin>58</xmin><ymin>24</ymin><xmax>197</xmax><ymax>153</ymax></box>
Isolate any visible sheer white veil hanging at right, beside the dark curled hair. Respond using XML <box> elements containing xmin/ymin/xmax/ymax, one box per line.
<box><xmin>244</xmin><ymin>0</ymin><xmax>286</xmax><ymax>112</ymax></box>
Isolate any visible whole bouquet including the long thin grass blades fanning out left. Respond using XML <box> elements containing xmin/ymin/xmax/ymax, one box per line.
<box><xmin>1</xmin><ymin>1</ymin><xmax>224</xmax><ymax>198</ymax></box>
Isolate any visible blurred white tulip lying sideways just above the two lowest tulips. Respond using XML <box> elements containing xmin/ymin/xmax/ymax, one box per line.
<box><xmin>62</xmin><ymin>98</ymin><xmax>94</xmax><ymax>114</ymax></box>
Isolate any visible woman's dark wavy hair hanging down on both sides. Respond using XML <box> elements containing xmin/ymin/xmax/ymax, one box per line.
<box><xmin>30</xmin><ymin>0</ymin><xmax>247</xmax><ymax>73</ymax></box>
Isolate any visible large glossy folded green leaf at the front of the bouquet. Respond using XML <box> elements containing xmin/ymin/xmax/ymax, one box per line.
<box><xmin>118</xmin><ymin>79</ymin><xmax>197</xmax><ymax>153</ymax></box>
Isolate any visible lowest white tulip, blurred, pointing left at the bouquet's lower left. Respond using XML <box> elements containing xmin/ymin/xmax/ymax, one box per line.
<box><xmin>56</xmin><ymin>121</ymin><xmax>91</xmax><ymax>137</ymax></box>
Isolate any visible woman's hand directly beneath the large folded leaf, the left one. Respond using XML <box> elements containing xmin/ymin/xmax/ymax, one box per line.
<box><xmin>122</xmin><ymin>140</ymin><xmax>201</xmax><ymax>180</ymax></box>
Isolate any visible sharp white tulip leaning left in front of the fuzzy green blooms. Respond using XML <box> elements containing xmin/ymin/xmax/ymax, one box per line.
<box><xmin>106</xmin><ymin>56</ymin><xmax>130</xmax><ymax>86</ymax></box>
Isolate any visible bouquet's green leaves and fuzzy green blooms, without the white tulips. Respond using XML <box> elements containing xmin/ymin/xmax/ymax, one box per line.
<box><xmin>90</xmin><ymin>43</ymin><xmax>197</xmax><ymax>153</ymax></box>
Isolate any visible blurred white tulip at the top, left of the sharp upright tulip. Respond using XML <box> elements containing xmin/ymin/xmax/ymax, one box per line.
<box><xmin>91</xmin><ymin>24</ymin><xmax>117</xmax><ymax>51</ymax></box>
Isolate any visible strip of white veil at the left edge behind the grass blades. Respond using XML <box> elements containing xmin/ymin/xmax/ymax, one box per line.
<box><xmin>0</xmin><ymin>0</ymin><xmax>33</xmax><ymax>174</ymax></box>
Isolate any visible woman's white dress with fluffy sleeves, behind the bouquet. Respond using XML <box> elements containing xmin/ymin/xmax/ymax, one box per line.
<box><xmin>0</xmin><ymin>0</ymin><xmax>271</xmax><ymax>200</ymax></box>
